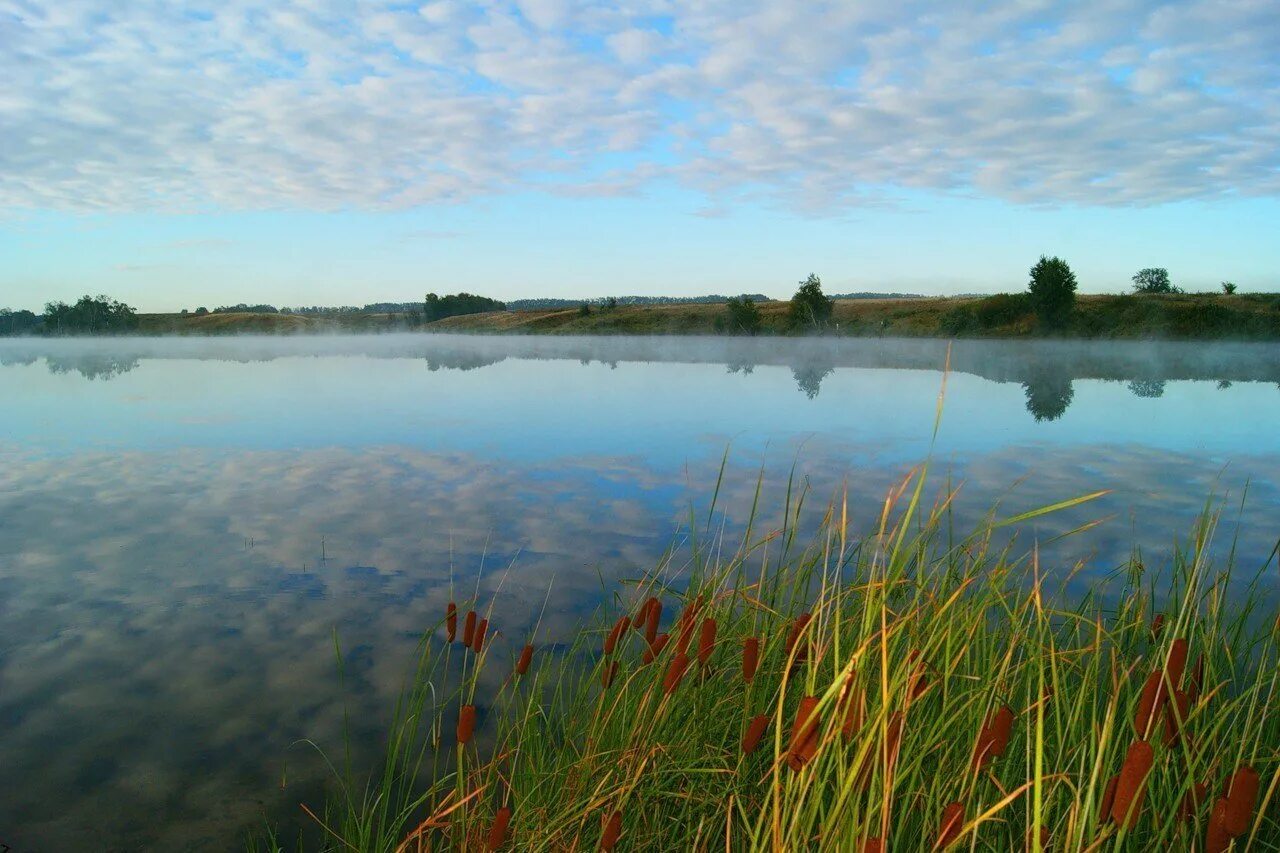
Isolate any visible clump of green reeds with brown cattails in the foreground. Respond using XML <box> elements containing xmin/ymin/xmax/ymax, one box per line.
<box><xmin>264</xmin><ymin>471</ymin><xmax>1280</xmax><ymax>852</ymax></box>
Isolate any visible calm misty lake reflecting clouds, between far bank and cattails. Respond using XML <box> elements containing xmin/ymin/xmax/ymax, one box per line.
<box><xmin>0</xmin><ymin>336</ymin><xmax>1280</xmax><ymax>852</ymax></box>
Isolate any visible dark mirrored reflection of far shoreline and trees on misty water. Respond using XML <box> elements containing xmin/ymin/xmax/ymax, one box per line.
<box><xmin>0</xmin><ymin>334</ymin><xmax>1280</xmax><ymax>421</ymax></box>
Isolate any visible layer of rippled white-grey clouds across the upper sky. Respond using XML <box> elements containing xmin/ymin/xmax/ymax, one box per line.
<box><xmin>0</xmin><ymin>0</ymin><xmax>1280</xmax><ymax>211</ymax></box>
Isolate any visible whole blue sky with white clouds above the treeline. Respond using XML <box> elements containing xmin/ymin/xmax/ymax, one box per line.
<box><xmin>0</xmin><ymin>0</ymin><xmax>1280</xmax><ymax>311</ymax></box>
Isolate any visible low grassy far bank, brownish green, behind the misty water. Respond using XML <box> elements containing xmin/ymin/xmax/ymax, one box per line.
<box><xmin>138</xmin><ymin>293</ymin><xmax>1280</xmax><ymax>339</ymax></box>
